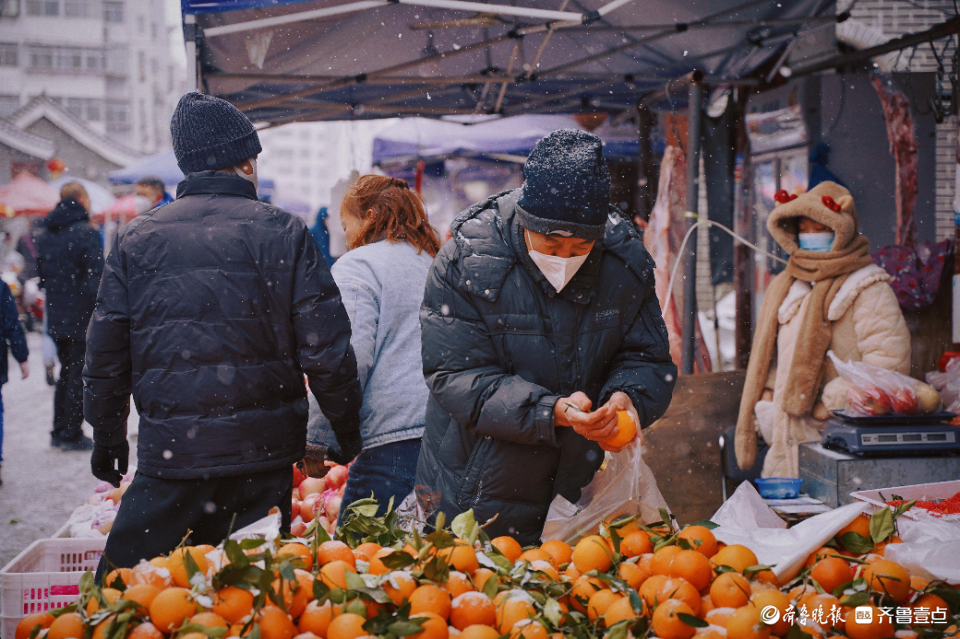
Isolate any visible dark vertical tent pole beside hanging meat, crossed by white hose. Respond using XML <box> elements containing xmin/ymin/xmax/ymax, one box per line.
<box><xmin>680</xmin><ymin>81</ymin><xmax>703</xmax><ymax>375</ymax></box>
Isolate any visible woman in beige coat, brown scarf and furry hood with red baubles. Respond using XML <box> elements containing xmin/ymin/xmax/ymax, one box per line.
<box><xmin>736</xmin><ymin>182</ymin><xmax>910</xmax><ymax>477</ymax></box>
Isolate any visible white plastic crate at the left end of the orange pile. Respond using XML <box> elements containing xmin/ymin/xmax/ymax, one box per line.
<box><xmin>0</xmin><ymin>538</ymin><xmax>107</xmax><ymax>639</ymax></box>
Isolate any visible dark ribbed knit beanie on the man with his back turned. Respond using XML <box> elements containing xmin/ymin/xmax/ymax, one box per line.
<box><xmin>170</xmin><ymin>93</ymin><xmax>263</xmax><ymax>174</ymax></box>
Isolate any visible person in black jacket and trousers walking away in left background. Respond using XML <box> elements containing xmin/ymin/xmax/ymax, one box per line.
<box><xmin>37</xmin><ymin>182</ymin><xmax>103</xmax><ymax>450</ymax></box>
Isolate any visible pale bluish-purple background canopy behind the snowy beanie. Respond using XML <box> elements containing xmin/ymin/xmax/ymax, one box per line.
<box><xmin>373</xmin><ymin>115</ymin><xmax>639</xmax><ymax>164</ymax></box>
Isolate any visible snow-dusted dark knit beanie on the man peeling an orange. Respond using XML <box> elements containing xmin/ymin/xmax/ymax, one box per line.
<box><xmin>517</xmin><ymin>129</ymin><xmax>610</xmax><ymax>240</ymax></box>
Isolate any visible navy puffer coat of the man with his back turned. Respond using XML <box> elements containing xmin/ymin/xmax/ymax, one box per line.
<box><xmin>83</xmin><ymin>171</ymin><xmax>362</xmax><ymax>479</ymax></box>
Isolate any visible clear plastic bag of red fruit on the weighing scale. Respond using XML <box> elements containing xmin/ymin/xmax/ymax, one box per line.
<box><xmin>827</xmin><ymin>351</ymin><xmax>940</xmax><ymax>417</ymax></box>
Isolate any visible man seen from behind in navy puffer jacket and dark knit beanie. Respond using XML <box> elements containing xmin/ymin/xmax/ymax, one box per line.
<box><xmin>84</xmin><ymin>93</ymin><xmax>362</xmax><ymax>568</ymax></box>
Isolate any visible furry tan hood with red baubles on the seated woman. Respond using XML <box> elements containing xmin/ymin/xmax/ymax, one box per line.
<box><xmin>767</xmin><ymin>182</ymin><xmax>859</xmax><ymax>255</ymax></box>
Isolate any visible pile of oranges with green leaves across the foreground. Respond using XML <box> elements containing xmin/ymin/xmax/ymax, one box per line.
<box><xmin>12</xmin><ymin>518</ymin><xmax>960</xmax><ymax>639</ymax></box>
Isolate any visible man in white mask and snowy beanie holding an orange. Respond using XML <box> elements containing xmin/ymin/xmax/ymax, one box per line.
<box><xmin>417</xmin><ymin>131</ymin><xmax>677</xmax><ymax>545</ymax></box>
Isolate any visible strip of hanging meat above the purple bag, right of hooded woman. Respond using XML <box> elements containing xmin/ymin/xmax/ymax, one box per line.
<box><xmin>873</xmin><ymin>76</ymin><xmax>918</xmax><ymax>247</ymax></box>
